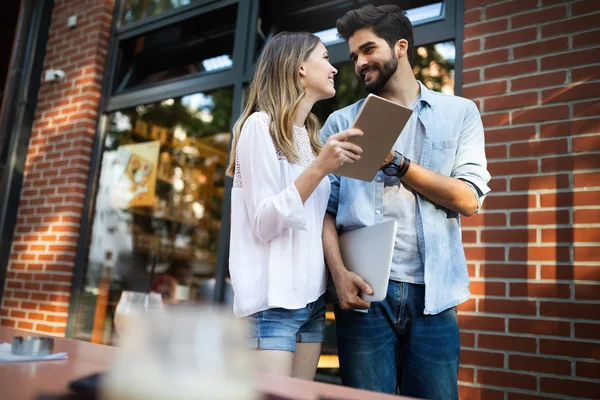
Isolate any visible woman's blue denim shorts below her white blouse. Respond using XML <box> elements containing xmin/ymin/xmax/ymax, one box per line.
<box><xmin>246</xmin><ymin>295</ymin><xmax>325</xmax><ymax>352</ymax></box>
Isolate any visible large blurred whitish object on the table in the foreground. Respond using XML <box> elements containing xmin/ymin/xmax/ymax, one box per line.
<box><xmin>102</xmin><ymin>306</ymin><xmax>259</xmax><ymax>400</ymax></box>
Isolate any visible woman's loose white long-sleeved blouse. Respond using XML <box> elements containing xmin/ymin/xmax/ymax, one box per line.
<box><xmin>229</xmin><ymin>112</ymin><xmax>330</xmax><ymax>317</ymax></box>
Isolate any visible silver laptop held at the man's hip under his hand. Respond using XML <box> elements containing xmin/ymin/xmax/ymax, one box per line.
<box><xmin>340</xmin><ymin>221</ymin><xmax>398</xmax><ymax>301</ymax></box>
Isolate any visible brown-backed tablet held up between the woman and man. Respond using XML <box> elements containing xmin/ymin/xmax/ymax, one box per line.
<box><xmin>334</xmin><ymin>94</ymin><xmax>412</xmax><ymax>182</ymax></box>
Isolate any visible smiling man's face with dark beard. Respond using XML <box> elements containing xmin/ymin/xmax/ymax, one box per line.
<box><xmin>348</xmin><ymin>29</ymin><xmax>398</xmax><ymax>94</ymax></box>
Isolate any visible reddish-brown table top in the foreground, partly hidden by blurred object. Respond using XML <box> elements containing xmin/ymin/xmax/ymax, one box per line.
<box><xmin>0</xmin><ymin>326</ymin><xmax>408</xmax><ymax>400</ymax></box>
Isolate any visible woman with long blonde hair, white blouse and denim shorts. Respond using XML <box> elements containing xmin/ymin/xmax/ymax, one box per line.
<box><xmin>227</xmin><ymin>32</ymin><xmax>362</xmax><ymax>380</ymax></box>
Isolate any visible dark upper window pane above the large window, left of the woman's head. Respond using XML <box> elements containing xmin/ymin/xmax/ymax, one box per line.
<box><xmin>115</xmin><ymin>4</ymin><xmax>237</xmax><ymax>93</ymax></box>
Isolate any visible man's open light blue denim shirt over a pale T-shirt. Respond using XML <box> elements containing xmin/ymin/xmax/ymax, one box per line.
<box><xmin>321</xmin><ymin>82</ymin><xmax>490</xmax><ymax>314</ymax></box>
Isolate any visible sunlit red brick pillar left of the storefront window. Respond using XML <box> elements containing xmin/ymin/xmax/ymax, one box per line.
<box><xmin>0</xmin><ymin>0</ymin><xmax>114</xmax><ymax>335</ymax></box>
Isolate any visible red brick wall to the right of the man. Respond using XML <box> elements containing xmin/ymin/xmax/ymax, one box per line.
<box><xmin>459</xmin><ymin>0</ymin><xmax>600</xmax><ymax>400</ymax></box>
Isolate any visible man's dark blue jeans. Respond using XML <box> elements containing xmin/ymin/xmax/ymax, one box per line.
<box><xmin>335</xmin><ymin>281</ymin><xmax>460</xmax><ymax>400</ymax></box>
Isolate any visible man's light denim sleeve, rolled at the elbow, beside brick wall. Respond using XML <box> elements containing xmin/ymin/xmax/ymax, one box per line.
<box><xmin>451</xmin><ymin>101</ymin><xmax>491</xmax><ymax>212</ymax></box>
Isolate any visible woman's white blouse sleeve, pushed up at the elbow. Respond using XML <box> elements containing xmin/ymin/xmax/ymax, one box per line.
<box><xmin>237</xmin><ymin>116</ymin><xmax>307</xmax><ymax>242</ymax></box>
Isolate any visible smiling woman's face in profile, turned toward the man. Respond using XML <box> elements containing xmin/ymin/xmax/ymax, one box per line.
<box><xmin>300</xmin><ymin>42</ymin><xmax>337</xmax><ymax>101</ymax></box>
